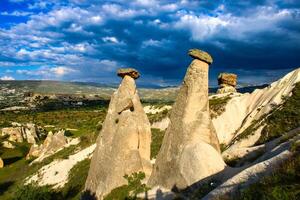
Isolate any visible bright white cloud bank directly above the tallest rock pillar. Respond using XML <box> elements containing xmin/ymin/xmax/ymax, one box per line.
<box><xmin>173</xmin><ymin>6</ymin><xmax>300</xmax><ymax>41</ymax></box>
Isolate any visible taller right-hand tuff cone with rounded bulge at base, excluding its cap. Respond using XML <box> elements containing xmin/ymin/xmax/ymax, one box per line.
<box><xmin>148</xmin><ymin>49</ymin><xmax>225</xmax><ymax>189</ymax></box>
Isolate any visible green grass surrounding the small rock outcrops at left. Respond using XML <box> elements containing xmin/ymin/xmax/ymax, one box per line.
<box><xmin>0</xmin><ymin>105</ymin><xmax>101</xmax><ymax>200</ymax></box>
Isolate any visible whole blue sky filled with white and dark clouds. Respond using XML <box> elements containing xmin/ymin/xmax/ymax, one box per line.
<box><xmin>0</xmin><ymin>0</ymin><xmax>300</xmax><ymax>86</ymax></box>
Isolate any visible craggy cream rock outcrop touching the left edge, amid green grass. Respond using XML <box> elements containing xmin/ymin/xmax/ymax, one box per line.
<box><xmin>1</xmin><ymin>122</ymin><xmax>41</xmax><ymax>144</ymax></box>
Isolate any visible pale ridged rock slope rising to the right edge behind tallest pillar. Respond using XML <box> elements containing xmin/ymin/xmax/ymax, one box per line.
<box><xmin>213</xmin><ymin>68</ymin><xmax>300</xmax><ymax>144</ymax></box>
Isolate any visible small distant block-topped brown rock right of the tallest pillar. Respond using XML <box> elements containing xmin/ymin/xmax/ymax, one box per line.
<box><xmin>217</xmin><ymin>73</ymin><xmax>237</xmax><ymax>94</ymax></box>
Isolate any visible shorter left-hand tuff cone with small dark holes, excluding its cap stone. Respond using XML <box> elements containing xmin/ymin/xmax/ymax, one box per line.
<box><xmin>85</xmin><ymin>69</ymin><xmax>151</xmax><ymax>199</ymax></box>
